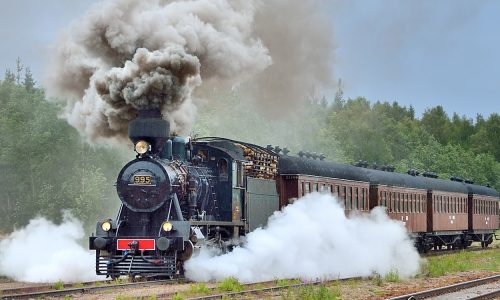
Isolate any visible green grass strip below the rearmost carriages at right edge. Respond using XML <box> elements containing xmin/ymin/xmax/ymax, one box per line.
<box><xmin>422</xmin><ymin>250</ymin><xmax>500</xmax><ymax>277</ymax></box>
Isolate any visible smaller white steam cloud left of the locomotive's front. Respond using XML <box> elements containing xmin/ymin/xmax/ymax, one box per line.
<box><xmin>0</xmin><ymin>213</ymin><xmax>99</xmax><ymax>282</ymax></box>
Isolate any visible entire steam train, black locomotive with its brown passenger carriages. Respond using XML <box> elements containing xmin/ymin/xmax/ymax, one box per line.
<box><xmin>89</xmin><ymin>110</ymin><xmax>499</xmax><ymax>278</ymax></box>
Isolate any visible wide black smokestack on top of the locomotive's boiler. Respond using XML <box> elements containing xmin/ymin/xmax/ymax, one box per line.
<box><xmin>128</xmin><ymin>108</ymin><xmax>170</xmax><ymax>153</ymax></box>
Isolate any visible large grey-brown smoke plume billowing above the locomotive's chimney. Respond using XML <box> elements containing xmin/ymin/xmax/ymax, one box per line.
<box><xmin>45</xmin><ymin>0</ymin><xmax>333</xmax><ymax>141</ymax></box>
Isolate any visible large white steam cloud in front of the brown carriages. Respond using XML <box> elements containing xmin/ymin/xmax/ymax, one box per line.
<box><xmin>185</xmin><ymin>193</ymin><xmax>420</xmax><ymax>282</ymax></box>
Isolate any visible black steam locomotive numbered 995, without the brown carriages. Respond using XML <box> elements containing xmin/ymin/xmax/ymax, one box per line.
<box><xmin>90</xmin><ymin>110</ymin><xmax>279</xmax><ymax>278</ymax></box>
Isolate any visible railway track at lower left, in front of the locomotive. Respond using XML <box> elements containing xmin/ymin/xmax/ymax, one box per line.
<box><xmin>0</xmin><ymin>279</ymin><xmax>186</xmax><ymax>299</ymax></box>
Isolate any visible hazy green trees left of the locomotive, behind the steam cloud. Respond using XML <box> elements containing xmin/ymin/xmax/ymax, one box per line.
<box><xmin>0</xmin><ymin>61</ymin><xmax>124</xmax><ymax>232</ymax></box>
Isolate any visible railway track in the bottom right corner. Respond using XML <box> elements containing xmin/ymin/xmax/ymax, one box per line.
<box><xmin>389</xmin><ymin>274</ymin><xmax>500</xmax><ymax>300</ymax></box>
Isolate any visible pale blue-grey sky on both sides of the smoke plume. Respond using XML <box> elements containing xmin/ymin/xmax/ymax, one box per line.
<box><xmin>0</xmin><ymin>0</ymin><xmax>500</xmax><ymax>118</ymax></box>
